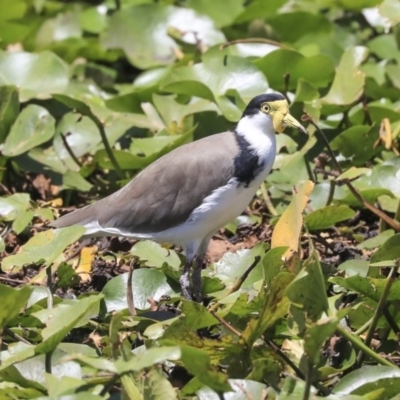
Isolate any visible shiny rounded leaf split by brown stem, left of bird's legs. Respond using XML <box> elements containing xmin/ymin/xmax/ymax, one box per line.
<box><xmin>102</xmin><ymin>268</ymin><xmax>176</xmax><ymax>312</ymax></box>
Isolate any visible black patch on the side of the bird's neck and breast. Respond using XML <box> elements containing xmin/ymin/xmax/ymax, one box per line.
<box><xmin>233</xmin><ymin>130</ymin><xmax>264</xmax><ymax>187</ymax></box>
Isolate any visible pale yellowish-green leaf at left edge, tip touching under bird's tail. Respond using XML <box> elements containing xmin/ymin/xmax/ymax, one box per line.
<box><xmin>1</xmin><ymin>226</ymin><xmax>86</xmax><ymax>272</ymax></box>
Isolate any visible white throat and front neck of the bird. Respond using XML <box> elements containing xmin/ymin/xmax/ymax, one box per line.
<box><xmin>235</xmin><ymin>111</ymin><xmax>276</xmax><ymax>164</ymax></box>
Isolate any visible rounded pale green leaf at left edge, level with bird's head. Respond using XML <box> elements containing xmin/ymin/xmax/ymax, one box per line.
<box><xmin>3</xmin><ymin>104</ymin><xmax>55</xmax><ymax>157</ymax></box>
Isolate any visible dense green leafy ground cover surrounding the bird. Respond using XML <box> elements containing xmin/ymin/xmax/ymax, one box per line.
<box><xmin>0</xmin><ymin>0</ymin><xmax>400</xmax><ymax>400</ymax></box>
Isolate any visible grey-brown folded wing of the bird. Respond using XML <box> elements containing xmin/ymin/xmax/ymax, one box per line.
<box><xmin>51</xmin><ymin>132</ymin><xmax>238</xmax><ymax>233</ymax></box>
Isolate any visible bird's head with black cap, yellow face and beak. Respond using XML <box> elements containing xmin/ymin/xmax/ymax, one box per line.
<box><xmin>243</xmin><ymin>93</ymin><xmax>307</xmax><ymax>133</ymax></box>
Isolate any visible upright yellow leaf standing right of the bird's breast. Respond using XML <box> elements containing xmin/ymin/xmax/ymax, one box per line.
<box><xmin>271</xmin><ymin>181</ymin><xmax>314</xmax><ymax>260</ymax></box>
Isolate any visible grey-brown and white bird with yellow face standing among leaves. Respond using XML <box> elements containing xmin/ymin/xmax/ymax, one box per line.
<box><xmin>50</xmin><ymin>92</ymin><xmax>307</xmax><ymax>303</ymax></box>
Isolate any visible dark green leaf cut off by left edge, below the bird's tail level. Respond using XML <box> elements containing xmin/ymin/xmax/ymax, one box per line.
<box><xmin>0</xmin><ymin>283</ymin><xmax>32</xmax><ymax>331</ymax></box>
